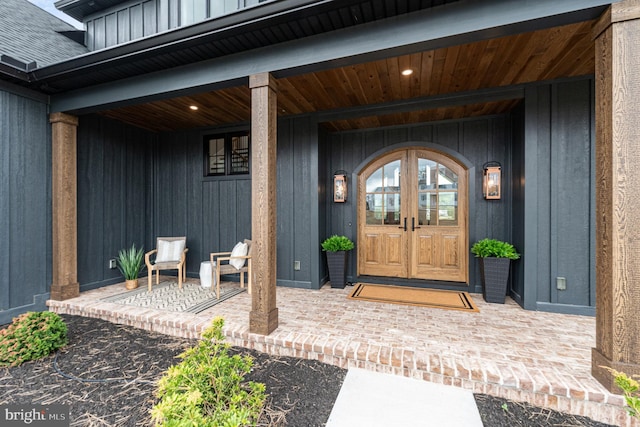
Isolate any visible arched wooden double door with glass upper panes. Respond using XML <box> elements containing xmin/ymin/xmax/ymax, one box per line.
<box><xmin>358</xmin><ymin>149</ymin><xmax>469</xmax><ymax>283</ymax></box>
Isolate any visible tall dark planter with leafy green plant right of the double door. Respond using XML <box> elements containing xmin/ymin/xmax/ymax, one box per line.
<box><xmin>471</xmin><ymin>239</ymin><xmax>520</xmax><ymax>304</ymax></box>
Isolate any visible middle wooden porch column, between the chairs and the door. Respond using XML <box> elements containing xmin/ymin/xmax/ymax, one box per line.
<box><xmin>249</xmin><ymin>73</ymin><xmax>278</xmax><ymax>335</ymax></box>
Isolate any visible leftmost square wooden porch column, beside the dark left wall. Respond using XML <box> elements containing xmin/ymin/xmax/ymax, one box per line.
<box><xmin>49</xmin><ymin>113</ymin><xmax>80</xmax><ymax>300</ymax></box>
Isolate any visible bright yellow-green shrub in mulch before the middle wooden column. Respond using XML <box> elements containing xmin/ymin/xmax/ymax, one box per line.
<box><xmin>151</xmin><ymin>317</ymin><xmax>266</xmax><ymax>427</ymax></box>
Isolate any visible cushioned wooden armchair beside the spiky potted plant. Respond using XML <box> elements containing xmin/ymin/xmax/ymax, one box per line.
<box><xmin>144</xmin><ymin>236</ymin><xmax>189</xmax><ymax>291</ymax></box>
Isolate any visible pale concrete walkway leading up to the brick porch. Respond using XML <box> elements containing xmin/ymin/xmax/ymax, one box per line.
<box><xmin>327</xmin><ymin>368</ymin><xmax>483</xmax><ymax>427</ymax></box>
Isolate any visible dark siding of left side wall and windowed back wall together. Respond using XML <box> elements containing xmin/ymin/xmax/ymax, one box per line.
<box><xmin>78</xmin><ymin>115</ymin><xmax>324</xmax><ymax>290</ymax></box>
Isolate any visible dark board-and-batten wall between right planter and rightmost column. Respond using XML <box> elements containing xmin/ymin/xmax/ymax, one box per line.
<box><xmin>514</xmin><ymin>79</ymin><xmax>595</xmax><ymax>315</ymax></box>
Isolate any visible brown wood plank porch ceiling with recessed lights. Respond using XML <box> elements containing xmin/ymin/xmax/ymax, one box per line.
<box><xmin>101</xmin><ymin>21</ymin><xmax>595</xmax><ymax>132</ymax></box>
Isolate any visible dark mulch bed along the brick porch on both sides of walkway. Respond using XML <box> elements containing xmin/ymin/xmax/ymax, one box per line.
<box><xmin>0</xmin><ymin>316</ymin><xmax>620</xmax><ymax>427</ymax></box>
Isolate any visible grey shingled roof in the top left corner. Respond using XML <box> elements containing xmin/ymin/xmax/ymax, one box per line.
<box><xmin>0</xmin><ymin>0</ymin><xmax>89</xmax><ymax>67</ymax></box>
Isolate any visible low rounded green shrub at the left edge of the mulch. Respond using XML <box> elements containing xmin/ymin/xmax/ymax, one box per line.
<box><xmin>0</xmin><ymin>311</ymin><xmax>67</xmax><ymax>366</ymax></box>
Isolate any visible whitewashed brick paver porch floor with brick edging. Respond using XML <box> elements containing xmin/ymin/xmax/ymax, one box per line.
<box><xmin>48</xmin><ymin>279</ymin><xmax>640</xmax><ymax>427</ymax></box>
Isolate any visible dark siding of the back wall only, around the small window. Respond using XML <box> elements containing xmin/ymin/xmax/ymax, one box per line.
<box><xmin>153</xmin><ymin>117</ymin><xmax>324</xmax><ymax>289</ymax></box>
